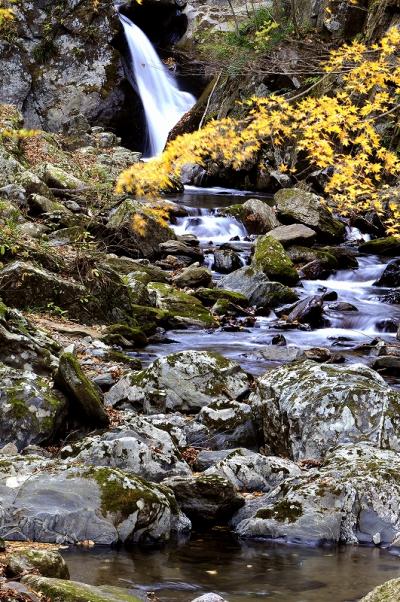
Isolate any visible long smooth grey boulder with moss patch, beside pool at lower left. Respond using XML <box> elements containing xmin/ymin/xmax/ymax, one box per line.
<box><xmin>0</xmin><ymin>456</ymin><xmax>190</xmax><ymax>545</ymax></box>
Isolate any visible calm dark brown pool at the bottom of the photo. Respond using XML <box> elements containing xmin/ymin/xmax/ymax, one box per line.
<box><xmin>64</xmin><ymin>531</ymin><xmax>400</xmax><ymax>602</ymax></box>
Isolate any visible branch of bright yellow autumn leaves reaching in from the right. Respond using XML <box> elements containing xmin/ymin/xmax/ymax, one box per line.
<box><xmin>117</xmin><ymin>27</ymin><xmax>400</xmax><ymax>234</ymax></box>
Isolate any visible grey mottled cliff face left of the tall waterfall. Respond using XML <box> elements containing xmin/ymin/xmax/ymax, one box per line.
<box><xmin>0</xmin><ymin>0</ymin><xmax>125</xmax><ymax>131</ymax></box>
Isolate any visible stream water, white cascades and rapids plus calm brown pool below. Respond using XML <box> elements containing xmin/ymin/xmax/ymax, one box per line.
<box><xmin>64</xmin><ymin>188</ymin><xmax>400</xmax><ymax>602</ymax></box>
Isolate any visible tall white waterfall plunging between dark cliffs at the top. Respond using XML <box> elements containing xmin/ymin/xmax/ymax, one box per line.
<box><xmin>120</xmin><ymin>14</ymin><xmax>196</xmax><ymax>156</ymax></box>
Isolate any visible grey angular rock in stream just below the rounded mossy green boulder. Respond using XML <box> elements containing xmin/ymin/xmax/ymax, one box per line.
<box><xmin>217</xmin><ymin>267</ymin><xmax>298</xmax><ymax>308</ymax></box>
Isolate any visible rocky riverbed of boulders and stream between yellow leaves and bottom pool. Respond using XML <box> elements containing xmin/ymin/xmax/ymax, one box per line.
<box><xmin>0</xmin><ymin>107</ymin><xmax>400</xmax><ymax>602</ymax></box>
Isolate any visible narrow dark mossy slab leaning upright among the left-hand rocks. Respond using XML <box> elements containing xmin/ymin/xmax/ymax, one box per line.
<box><xmin>56</xmin><ymin>353</ymin><xmax>109</xmax><ymax>427</ymax></box>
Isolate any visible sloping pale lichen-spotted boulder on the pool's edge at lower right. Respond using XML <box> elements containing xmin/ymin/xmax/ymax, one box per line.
<box><xmin>232</xmin><ymin>443</ymin><xmax>400</xmax><ymax>545</ymax></box>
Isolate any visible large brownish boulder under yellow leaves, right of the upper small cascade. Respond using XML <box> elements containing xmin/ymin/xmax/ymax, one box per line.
<box><xmin>274</xmin><ymin>188</ymin><xmax>345</xmax><ymax>242</ymax></box>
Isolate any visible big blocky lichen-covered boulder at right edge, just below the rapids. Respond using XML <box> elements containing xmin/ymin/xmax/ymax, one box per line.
<box><xmin>251</xmin><ymin>361</ymin><xmax>400</xmax><ymax>460</ymax></box>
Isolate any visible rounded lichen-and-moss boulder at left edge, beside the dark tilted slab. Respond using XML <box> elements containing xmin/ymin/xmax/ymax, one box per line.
<box><xmin>0</xmin><ymin>364</ymin><xmax>67</xmax><ymax>450</ymax></box>
